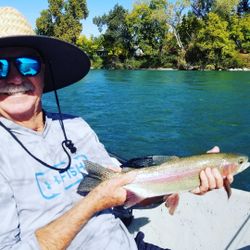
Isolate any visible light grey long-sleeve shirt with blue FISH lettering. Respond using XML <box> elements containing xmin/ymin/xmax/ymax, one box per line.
<box><xmin>0</xmin><ymin>113</ymin><xmax>137</xmax><ymax>250</ymax></box>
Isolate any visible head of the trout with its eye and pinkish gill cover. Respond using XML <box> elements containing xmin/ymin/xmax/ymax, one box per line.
<box><xmin>221</xmin><ymin>154</ymin><xmax>250</xmax><ymax>176</ymax></box>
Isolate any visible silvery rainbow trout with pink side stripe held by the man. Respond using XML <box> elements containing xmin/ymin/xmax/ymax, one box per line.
<box><xmin>77</xmin><ymin>153</ymin><xmax>250</xmax><ymax>208</ymax></box>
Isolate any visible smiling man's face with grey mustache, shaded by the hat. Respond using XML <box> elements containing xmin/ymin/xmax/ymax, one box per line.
<box><xmin>0</xmin><ymin>47</ymin><xmax>44</xmax><ymax>121</ymax></box>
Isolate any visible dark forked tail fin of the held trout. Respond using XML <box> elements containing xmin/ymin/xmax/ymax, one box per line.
<box><xmin>77</xmin><ymin>160</ymin><xmax>115</xmax><ymax>195</ymax></box>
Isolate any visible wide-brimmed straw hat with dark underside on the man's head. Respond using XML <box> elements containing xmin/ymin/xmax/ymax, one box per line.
<box><xmin>0</xmin><ymin>7</ymin><xmax>90</xmax><ymax>93</ymax></box>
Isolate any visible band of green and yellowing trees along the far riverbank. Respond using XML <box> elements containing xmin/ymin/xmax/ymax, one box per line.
<box><xmin>37</xmin><ymin>0</ymin><xmax>250</xmax><ymax>70</ymax></box>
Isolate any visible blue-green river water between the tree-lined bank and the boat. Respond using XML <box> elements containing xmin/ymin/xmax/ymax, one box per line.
<box><xmin>44</xmin><ymin>70</ymin><xmax>250</xmax><ymax>191</ymax></box>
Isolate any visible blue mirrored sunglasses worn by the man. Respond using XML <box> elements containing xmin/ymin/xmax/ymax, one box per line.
<box><xmin>0</xmin><ymin>56</ymin><xmax>41</xmax><ymax>79</ymax></box>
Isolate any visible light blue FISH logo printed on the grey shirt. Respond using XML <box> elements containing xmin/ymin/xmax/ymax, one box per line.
<box><xmin>35</xmin><ymin>155</ymin><xmax>87</xmax><ymax>200</ymax></box>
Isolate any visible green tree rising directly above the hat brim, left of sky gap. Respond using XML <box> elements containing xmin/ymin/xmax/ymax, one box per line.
<box><xmin>36</xmin><ymin>0</ymin><xmax>88</xmax><ymax>44</ymax></box>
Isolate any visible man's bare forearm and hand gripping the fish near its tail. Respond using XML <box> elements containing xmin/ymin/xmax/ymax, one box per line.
<box><xmin>35</xmin><ymin>169</ymin><xmax>135</xmax><ymax>250</ymax></box>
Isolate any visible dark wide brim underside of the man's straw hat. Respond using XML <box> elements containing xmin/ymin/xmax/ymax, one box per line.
<box><xmin>0</xmin><ymin>35</ymin><xmax>90</xmax><ymax>93</ymax></box>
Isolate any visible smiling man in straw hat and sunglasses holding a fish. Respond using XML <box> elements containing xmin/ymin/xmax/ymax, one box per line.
<box><xmin>0</xmin><ymin>7</ymin><xmax>232</xmax><ymax>250</ymax></box>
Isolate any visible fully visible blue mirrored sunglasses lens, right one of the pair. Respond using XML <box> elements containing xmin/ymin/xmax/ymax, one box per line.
<box><xmin>16</xmin><ymin>57</ymin><xmax>41</xmax><ymax>76</ymax></box>
